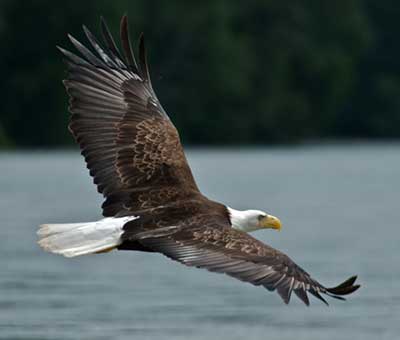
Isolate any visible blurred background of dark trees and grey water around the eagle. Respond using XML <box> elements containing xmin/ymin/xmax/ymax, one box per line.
<box><xmin>0</xmin><ymin>0</ymin><xmax>400</xmax><ymax>340</ymax></box>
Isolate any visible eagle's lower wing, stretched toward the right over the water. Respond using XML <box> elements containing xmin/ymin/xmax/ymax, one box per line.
<box><xmin>134</xmin><ymin>216</ymin><xmax>359</xmax><ymax>305</ymax></box>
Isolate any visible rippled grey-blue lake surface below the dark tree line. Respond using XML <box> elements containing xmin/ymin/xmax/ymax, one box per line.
<box><xmin>0</xmin><ymin>144</ymin><xmax>400</xmax><ymax>340</ymax></box>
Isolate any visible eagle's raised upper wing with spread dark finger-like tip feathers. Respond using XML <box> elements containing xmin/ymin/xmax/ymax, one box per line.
<box><xmin>59</xmin><ymin>16</ymin><xmax>198</xmax><ymax>216</ymax></box>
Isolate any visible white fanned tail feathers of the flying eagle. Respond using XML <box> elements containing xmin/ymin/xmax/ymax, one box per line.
<box><xmin>37</xmin><ymin>216</ymin><xmax>137</xmax><ymax>257</ymax></box>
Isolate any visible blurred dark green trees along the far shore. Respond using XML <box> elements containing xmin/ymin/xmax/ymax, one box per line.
<box><xmin>0</xmin><ymin>0</ymin><xmax>400</xmax><ymax>147</ymax></box>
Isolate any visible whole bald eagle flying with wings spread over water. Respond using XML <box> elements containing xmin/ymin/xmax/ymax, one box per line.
<box><xmin>38</xmin><ymin>16</ymin><xmax>359</xmax><ymax>305</ymax></box>
